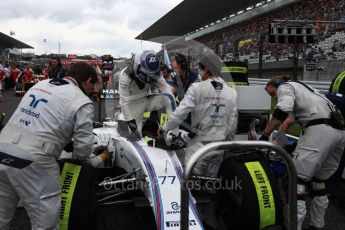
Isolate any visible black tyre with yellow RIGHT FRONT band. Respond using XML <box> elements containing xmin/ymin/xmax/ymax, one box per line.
<box><xmin>59</xmin><ymin>159</ymin><xmax>97</xmax><ymax>230</ymax></box>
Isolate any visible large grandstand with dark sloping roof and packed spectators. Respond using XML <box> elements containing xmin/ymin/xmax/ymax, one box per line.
<box><xmin>137</xmin><ymin>0</ymin><xmax>345</xmax><ymax>80</ymax></box>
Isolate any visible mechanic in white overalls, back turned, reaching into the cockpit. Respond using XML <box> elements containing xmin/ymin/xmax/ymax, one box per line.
<box><xmin>158</xmin><ymin>54</ymin><xmax>238</xmax><ymax>177</ymax></box>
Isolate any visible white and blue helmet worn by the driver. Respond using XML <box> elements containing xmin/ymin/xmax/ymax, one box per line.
<box><xmin>133</xmin><ymin>50</ymin><xmax>161</xmax><ymax>83</ymax></box>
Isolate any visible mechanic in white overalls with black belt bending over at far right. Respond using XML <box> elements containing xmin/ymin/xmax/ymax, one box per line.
<box><xmin>260</xmin><ymin>76</ymin><xmax>345</xmax><ymax>229</ymax></box>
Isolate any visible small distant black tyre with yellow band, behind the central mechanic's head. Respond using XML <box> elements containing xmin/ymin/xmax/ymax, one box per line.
<box><xmin>221</xmin><ymin>61</ymin><xmax>249</xmax><ymax>85</ymax></box>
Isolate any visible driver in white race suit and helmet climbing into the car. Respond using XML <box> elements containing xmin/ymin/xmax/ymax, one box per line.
<box><xmin>119</xmin><ymin>50</ymin><xmax>176</xmax><ymax>137</ymax></box>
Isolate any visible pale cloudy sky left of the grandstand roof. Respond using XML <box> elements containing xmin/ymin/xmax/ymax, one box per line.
<box><xmin>0</xmin><ymin>0</ymin><xmax>182</xmax><ymax>57</ymax></box>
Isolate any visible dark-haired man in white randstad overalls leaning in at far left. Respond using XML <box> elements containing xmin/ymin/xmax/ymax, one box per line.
<box><xmin>0</xmin><ymin>63</ymin><xmax>106</xmax><ymax>229</ymax></box>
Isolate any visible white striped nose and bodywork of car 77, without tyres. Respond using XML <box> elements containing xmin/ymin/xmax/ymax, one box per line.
<box><xmin>94</xmin><ymin>121</ymin><xmax>203</xmax><ymax>229</ymax></box>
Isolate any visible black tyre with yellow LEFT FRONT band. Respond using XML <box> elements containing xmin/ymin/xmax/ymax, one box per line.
<box><xmin>217</xmin><ymin>150</ymin><xmax>283</xmax><ymax>230</ymax></box>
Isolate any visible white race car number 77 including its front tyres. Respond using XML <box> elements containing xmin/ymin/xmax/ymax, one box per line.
<box><xmin>60</xmin><ymin>117</ymin><xmax>290</xmax><ymax>230</ymax></box>
